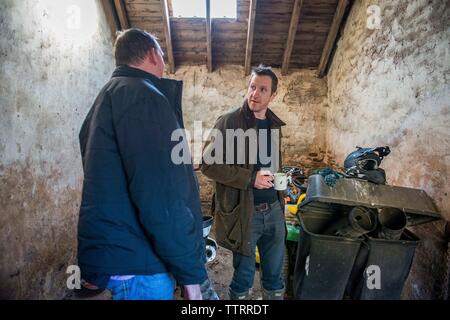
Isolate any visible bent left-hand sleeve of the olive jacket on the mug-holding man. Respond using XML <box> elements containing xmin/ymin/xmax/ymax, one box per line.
<box><xmin>201</xmin><ymin>117</ymin><xmax>256</xmax><ymax>190</ymax></box>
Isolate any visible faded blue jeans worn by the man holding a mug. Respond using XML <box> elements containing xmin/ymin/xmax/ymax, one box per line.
<box><xmin>230</xmin><ymin>202</ymin><xmax>286</xmax><ymax>293</ymax></box>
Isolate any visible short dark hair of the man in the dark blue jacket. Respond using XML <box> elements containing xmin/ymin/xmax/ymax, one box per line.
<box><xmin>114</xmin><ymin>28</ymin><xmax>161</xmax><ymax>66</ymax></box>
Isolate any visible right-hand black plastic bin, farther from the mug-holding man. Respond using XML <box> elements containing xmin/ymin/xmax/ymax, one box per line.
<box><xmin>347</xmin><ymin>230</ymin><xmax>419</xmax><ymax>300</ymax></box>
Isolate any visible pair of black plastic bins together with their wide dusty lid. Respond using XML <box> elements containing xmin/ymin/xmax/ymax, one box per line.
<box><xmin>293</xmin><ymin>175</ymin><xmax>440</xmax><ymax>300</ymax></box>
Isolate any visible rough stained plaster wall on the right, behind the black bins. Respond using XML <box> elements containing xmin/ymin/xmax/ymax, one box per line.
<box><xmin>327</xmin><ymin>0</ymin><xmax>450</xmax><ymax>299</ymax></box>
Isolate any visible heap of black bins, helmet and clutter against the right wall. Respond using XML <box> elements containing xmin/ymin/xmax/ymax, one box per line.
<box><xmin>280</xmin><ymin>147</ymin><xmax>441</xmax><ymax>300</ymax></box>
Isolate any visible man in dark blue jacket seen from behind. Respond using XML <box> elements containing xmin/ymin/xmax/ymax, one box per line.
<box><xmin>78</xmin><ymin>29</ymin><xmax>207</xmax><ymax>300</ymax></box>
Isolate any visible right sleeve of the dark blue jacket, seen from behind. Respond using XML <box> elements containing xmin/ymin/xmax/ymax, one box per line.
<box><xmin>113</xmin><ymin>92</ymin><xmax>207</xmax><ymax>285</ymax></box>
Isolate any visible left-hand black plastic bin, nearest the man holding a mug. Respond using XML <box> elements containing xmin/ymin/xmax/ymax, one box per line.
<box><xmin>293</xmin><ymin>206</ymin><xmax>362</xmax><ymax>300</ymax></box>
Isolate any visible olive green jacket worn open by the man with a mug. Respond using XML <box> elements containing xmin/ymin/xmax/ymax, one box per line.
<box><xmin>201</xmin><ymin>102</ymin><xmax>285</xmax><ymax>256</ymax></box>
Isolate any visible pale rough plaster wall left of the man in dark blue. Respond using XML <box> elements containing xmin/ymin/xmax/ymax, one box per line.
<box><xmin>0</xmin><ymin>0</ymin><xmax>114</xmax><ymax>299</ymax></box>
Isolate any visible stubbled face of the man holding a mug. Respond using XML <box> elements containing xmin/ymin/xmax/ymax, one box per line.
<box><xmin>247</xmin><ymin>75</ymin><xmax>276</xmax><ymax>118</ymax></box>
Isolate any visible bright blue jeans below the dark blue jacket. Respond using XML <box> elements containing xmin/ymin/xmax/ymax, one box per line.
<box><xmin>107</xmin><ymin>273</ymin><xmax>175</xmax><ymax>300</ymax></box>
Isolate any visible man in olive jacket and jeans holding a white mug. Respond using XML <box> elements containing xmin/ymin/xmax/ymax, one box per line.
<box><xmin>201</xmin><ymin>66</ymin><xmax>286</xmax><ymax>299</ymax></box>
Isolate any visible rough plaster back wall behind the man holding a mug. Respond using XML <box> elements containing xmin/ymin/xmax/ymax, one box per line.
<box><xmin>169</xmin><ymin>66</ymin><xmax>327</xmax><ymax>202</ymax></box>
